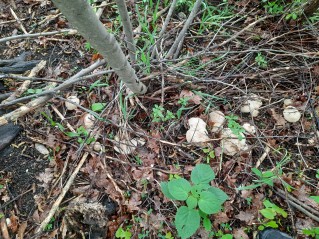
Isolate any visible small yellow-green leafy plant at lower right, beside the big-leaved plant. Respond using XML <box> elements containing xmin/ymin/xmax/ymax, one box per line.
<box><xmin>258</xmin><ymin>199</ymin><xmax>288</xmax><ymax>230</ymax></box>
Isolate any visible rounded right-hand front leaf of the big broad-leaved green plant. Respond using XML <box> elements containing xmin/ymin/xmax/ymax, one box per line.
<box><xmin>198</xmin><ymin>191</ymin><xmax>222</xmax><ymax>214</ymax></box>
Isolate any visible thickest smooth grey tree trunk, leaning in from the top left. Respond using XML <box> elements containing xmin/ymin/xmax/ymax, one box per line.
<box><xmin>52</xmin><ymin>0</ymin><xmax>147</xmax><ymax>94</ymax></box>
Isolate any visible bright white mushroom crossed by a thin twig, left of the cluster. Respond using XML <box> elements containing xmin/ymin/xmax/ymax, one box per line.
<box><xmin>186</xmin><ymin>118</ymin><xmax>209</xmax><ymax>144</ymax></box>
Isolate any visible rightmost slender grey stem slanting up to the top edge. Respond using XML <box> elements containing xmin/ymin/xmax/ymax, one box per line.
<box><xmin>165</xmin><ymin>0</ymin><xmax>203</xmax><ymax>59</ymax></box>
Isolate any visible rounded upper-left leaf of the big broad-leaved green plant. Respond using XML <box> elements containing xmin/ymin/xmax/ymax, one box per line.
<box><xmin>168</xmin><ymin>178</ymin><xmax>191</xmax><ymax>201</ymax></box>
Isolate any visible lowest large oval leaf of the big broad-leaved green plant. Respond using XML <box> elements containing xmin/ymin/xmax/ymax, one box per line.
<box><xmin>175</xmin><ymin>206</ymin><xmax>200</xmax><ymax>239</ymax></box>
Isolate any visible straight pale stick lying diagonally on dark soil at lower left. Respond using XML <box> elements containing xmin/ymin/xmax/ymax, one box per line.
<box><xmin>36</xmin><ymin>152</ymin><xmax>89</xmax><ymax>233</ymax></box>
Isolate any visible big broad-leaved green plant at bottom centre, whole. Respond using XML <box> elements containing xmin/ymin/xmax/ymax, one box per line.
<box><xmin>161</xmin><ymin>164</ymin><xmax>228</xmax><ymax>238</ymax></box>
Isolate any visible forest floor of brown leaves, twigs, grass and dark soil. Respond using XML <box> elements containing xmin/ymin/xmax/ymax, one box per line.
<box><xmin>0</xmin><ymin>0</ymin><xmax>319</xmax><ymax>239</ymax></box>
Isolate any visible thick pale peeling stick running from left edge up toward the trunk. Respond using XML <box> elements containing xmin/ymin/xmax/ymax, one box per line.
<box><xmin>0</xmin><ymin>60</ymin><xmax>105</xmax><ymax>126</ymax></box>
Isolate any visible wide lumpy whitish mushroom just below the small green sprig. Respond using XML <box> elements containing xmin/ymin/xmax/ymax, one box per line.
<box><xmin>221</xmin><ymin>128</ymin><xmax>248</xmax><ymax>156</ymax></box>
